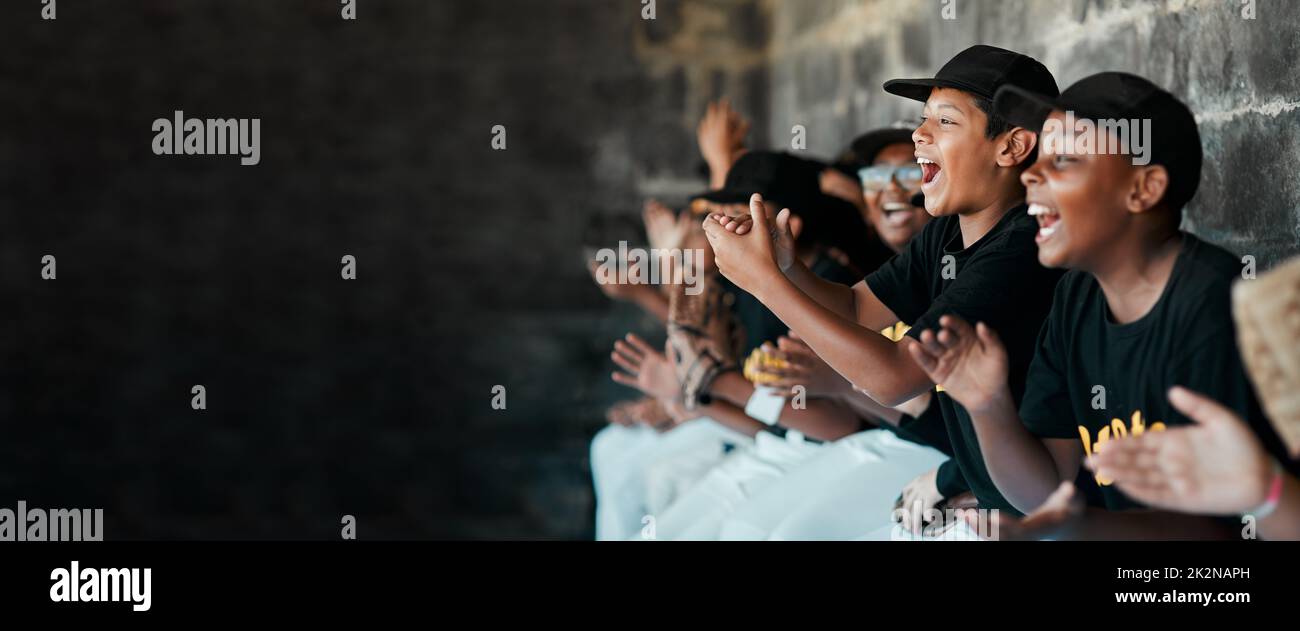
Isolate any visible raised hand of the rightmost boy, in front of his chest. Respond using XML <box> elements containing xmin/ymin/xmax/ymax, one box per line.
<box><xmin>904</xmin><ymin>315</ymin><xmax>1008</xmax><ymax>412</ymax></box>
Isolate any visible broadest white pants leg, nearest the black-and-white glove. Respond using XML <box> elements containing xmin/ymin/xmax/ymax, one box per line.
<box><xmin>719</xmin><ymin>429</ymin><xmax>948</xmax><ymax>540</ymax></box>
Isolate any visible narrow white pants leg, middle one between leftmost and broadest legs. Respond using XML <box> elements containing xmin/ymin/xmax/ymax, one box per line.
<box><xmin>634</xmin><ymin>432</ymin><xmax>826</xmax><ymax>540</ymax></box>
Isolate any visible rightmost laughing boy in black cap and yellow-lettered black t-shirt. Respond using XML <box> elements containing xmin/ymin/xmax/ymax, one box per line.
<box><xmin>913</xmin><ymin>73</ymin><xmax>1281</xmax><ymax>539</ymax></box>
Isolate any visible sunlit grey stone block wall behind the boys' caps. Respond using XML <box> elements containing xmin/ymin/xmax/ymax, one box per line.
<box><xmin>770</xmin><ymin>0</ymin><xmax>1300</xmax><ymax>265</ymax></box>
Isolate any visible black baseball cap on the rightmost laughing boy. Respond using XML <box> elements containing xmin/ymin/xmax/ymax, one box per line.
<box><xmin>993</xmin><ymin>72</ymin><xmax>1204</xmax><ymax>209</ymax></box>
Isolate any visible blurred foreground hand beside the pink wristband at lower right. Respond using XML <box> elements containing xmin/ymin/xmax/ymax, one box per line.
<box><xmin>1087</xmin><ymin>388</ymin><xmax>1273</xmax><ymax>515</ymax></box>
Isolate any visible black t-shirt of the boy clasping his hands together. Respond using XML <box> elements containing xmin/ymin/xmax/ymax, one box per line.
<box><xmin>867</xmin><ymin>204</ymin><xmax>1061</xmax><ymax>514</ymax></box>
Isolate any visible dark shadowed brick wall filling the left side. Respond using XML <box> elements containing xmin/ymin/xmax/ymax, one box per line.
<box><xmin>0</xmin><ymin>0</ymin><xmax>767</xmax><ymax>539</ymax></box>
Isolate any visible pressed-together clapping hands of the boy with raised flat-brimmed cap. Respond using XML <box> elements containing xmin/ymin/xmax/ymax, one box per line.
<box><xmin>705</xmin><ymin>193</ymin><xmax>794</xmax><ymax>295</ymax></box>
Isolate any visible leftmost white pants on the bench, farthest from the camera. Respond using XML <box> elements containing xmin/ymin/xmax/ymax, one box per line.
<box><xmin>592</xmin><ymin>418</ymin><xmax>753</xmax><ymax>541</ymax></box>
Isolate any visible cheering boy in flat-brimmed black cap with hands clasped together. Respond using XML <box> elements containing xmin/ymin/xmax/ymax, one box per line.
<box><xmin>705</xmin><ymin>46</ymin><xmax>1060</xmax><ymax>530</ymax></box>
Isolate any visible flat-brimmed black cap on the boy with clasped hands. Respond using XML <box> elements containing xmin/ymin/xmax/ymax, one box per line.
<box><xmin>884</xmin><ymin>44</ymin><xmax>1060</xmax><ymax>103</ymax></box>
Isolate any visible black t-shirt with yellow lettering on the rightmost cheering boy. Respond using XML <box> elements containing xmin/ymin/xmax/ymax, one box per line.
<box><xmin>1021</xmin><ymin>234</ymin><xmax>1286</xmax><ymax>510</ymax></box>
